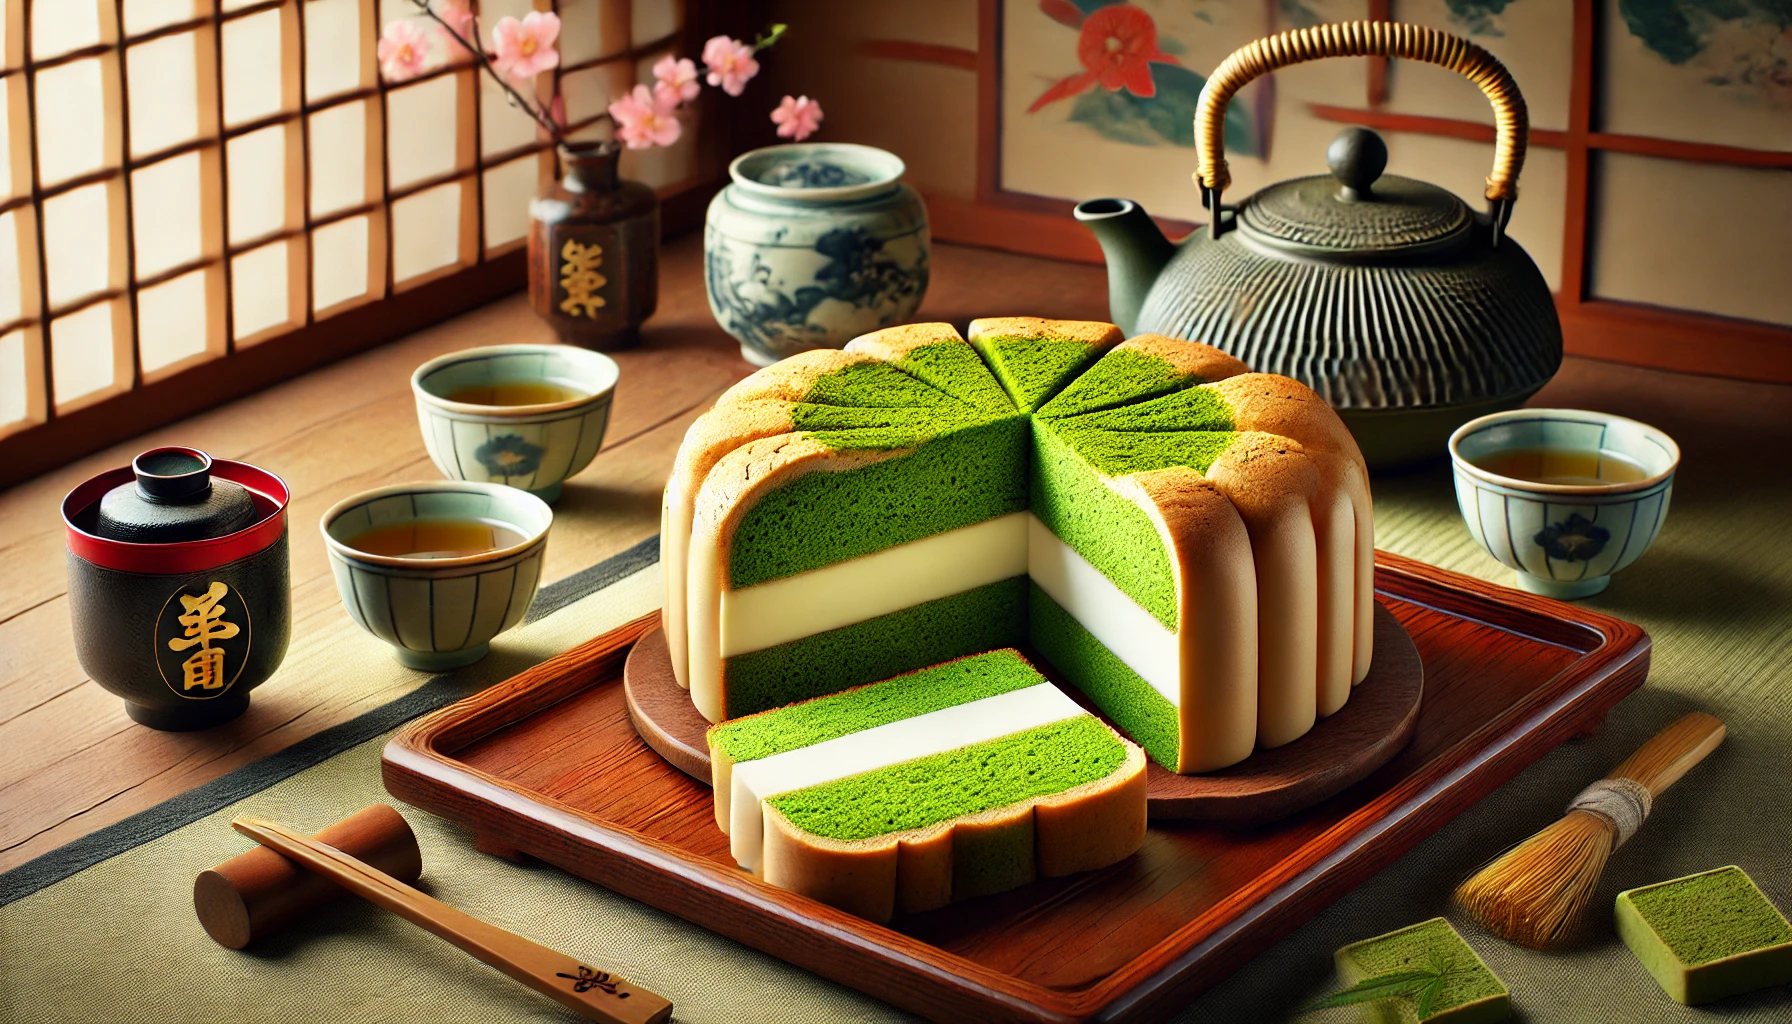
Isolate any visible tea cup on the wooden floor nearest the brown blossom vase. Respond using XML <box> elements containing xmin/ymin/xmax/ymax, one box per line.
<box><xmin>410</xmin><ymin>344</ymin><xmax>618</xmax><ymax>502</ymax></box>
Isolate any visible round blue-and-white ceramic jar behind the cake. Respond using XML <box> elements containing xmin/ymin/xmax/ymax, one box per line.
<box><xmin>702</xmin><ymin>142</ymin><xmax>928</xmax><ymax>366</ymax></box>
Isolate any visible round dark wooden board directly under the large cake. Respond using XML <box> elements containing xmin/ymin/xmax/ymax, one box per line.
<box><xmin>622</xmin><ymin>604</ymin><xmax>1425</xmax><ymax>825</ymax></box>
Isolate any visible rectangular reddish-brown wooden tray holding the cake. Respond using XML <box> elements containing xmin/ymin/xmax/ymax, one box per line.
<box><xmin>383</xmin><ymin>552</ymin><xmax>1649</xmax><ymax>1020</ymax></box>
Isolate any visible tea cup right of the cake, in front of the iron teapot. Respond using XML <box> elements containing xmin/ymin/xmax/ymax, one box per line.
<box><xmin>1450</xmin><ymin>409</ymin><xmax>1679</xmax><ymax>601</ymax></box>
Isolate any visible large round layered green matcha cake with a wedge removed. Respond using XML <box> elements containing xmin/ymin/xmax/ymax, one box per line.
<box><xmin>661</xmin><ymin>317</ymin><xmax>1374</xmax><ymax>773</ymax></box>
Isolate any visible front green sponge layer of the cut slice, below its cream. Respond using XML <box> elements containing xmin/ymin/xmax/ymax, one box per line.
<box><xmin>767</xmin><ymin>716</ymin><xmax>1125</xmax><ymax>841</ymax></box>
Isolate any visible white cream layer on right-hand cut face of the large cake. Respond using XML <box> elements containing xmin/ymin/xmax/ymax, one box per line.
<box><xmin>1027</xmin><ymin>513</ymin><xmax>1183</xmax><ymax>707</ymax></box>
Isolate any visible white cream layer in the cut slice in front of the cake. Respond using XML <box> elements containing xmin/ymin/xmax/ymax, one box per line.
<box><xmin>728</xmin><ymin>683</ymin><xmax>1088</xmax><ymax>872</ymax></box>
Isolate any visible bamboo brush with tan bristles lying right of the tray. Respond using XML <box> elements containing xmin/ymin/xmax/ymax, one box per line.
<box><xmin>1455</xmin><ymin>712</ymin><xmax>1724</xmax><ymax>949</ymax></box>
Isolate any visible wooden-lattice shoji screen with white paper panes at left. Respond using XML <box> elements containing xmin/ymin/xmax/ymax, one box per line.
<box><xmin>0</xmin><ymin>0</ymin><xmax>713</xmax><ymax>482</ymax></box>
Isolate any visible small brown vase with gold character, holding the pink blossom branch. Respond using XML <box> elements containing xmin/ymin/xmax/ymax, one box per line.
<box><xmin>529</xmin><ymin>143</ymin><xmax>659</xmax><ymax>351</ymax></box>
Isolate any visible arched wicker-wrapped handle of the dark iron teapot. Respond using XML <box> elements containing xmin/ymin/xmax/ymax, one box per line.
<box><xmin>1195</xmin><ymin>22</ymin><xmax>1530</xmax><ymax>206</ymax></box>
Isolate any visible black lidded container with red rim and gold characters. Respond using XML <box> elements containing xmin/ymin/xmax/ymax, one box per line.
<box><xmin>63</xmin><ymin>447</ymin><xmax>292</xmax><ymax>730</ymax></box>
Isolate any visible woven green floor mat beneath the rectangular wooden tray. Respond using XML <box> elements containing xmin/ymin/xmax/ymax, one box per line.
<box><xmin>0</xmin><ymin>454</ymin><xmax>1792</xmax><ymax>1024</ymax></box>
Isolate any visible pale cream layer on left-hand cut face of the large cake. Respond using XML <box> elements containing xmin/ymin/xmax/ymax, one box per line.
<box><xmin>722</xmin><ymin>511</ymin><xmax>1032</xmax><ymax>658</ymax></box>
